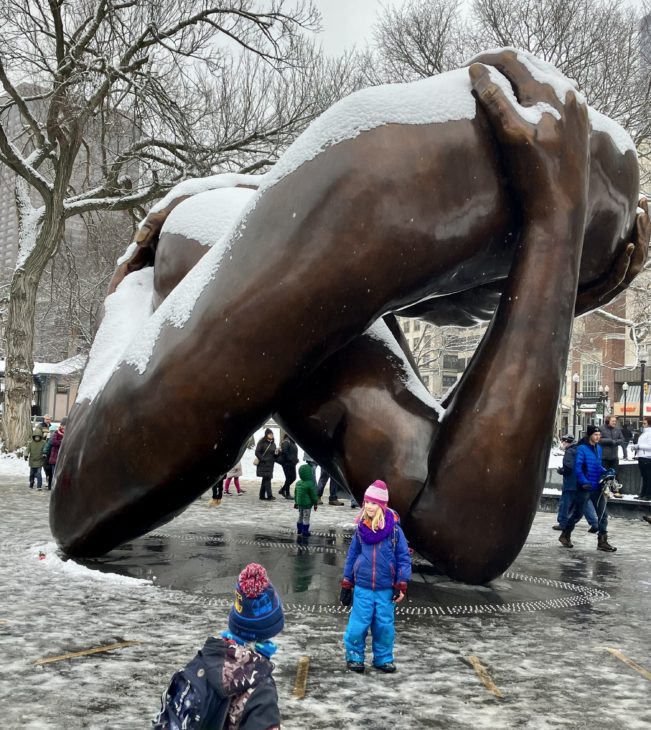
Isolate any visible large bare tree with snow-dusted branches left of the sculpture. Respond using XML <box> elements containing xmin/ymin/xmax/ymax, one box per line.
<box><xmin>0</xmin><ymin>0</ymin><xmax>360</xmax><ymax>450</ymax></box>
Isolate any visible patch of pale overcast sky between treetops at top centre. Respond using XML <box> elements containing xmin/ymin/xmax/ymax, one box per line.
<box><xmin>315</xmin><ymin>0</ymin><xmax>382</xmax><ymax>54</ymax></box>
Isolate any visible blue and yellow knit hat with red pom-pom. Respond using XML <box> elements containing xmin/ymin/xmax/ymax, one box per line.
<box><xmin>228</xmin><ymin>563</ymin><xmax>285</xmax><ymax>641</ymax></box>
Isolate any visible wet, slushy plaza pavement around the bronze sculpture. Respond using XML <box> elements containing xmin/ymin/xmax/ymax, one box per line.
<box><xmin>0</xmin><ymin>464</ymin><xmax>651</xmax><ymax>730</ymax></box>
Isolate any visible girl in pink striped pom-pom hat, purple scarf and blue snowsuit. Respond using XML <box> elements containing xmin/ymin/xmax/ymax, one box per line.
<box><xmin>341</xmin><ymin>479</ymin><xmax>411</xmax><ymax>673</ymax></box>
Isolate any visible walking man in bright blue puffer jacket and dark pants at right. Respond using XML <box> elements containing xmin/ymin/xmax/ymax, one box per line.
<box><xmin>558</xmin><ymin>425</ymin><xmax>617</xmax><ymax>553</ymax></box>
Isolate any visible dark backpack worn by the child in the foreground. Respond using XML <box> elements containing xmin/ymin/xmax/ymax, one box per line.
<box><xmin>152</xmin><ymin>654</ymin><xmax>230</xmax><ymax>730</ymax></box>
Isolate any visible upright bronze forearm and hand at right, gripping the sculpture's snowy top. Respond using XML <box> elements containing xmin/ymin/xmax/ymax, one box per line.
<box><xmin>405</xmin><ymin>55</ymin><xmax>589</xmax><ymax>582</ymax></box>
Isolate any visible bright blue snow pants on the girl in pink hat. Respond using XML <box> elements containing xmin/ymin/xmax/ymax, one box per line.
<box><xmin>344</xmin><ymin>586</ymin><xmax>396</xmax><ymax>666</ymax></box>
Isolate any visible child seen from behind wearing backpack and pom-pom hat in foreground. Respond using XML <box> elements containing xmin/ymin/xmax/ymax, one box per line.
<box><xmin>152</xmin><ymin>563</ymin><xmax>285</xmax><ymax>730</ymax></box>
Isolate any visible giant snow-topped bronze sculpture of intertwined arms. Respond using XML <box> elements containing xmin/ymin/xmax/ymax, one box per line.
<box><xmin>50</xmin><ymin>50</ymin><xmax>650</xmax><ymax>583</ymax></box>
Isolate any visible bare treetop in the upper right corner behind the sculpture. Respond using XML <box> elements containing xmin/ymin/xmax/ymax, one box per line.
<box><xmin>469</xmin><ymin>0</ymin><xmax>651</xmax><ymax>182</ymax></box>
